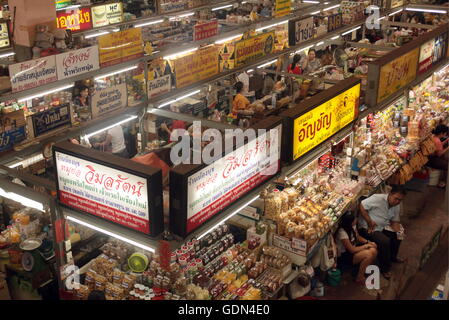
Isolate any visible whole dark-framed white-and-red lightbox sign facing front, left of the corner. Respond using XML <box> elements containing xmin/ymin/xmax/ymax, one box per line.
<box><xmin>53</xmin><ymin>142</ymin><xmax>163</xmax><ymax>236</ymax></box>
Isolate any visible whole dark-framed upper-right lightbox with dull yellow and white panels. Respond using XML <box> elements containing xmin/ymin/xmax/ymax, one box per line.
<box><xmin>366</xmin><ymin>24</ymin><xmax>449</xmax><ymax>106</ymax></box>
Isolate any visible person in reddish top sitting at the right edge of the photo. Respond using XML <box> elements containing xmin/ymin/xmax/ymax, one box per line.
<box><xmin>426</xmin><ymin>124</ymin><xmax>449</xmax><ymax>188</ymax></box>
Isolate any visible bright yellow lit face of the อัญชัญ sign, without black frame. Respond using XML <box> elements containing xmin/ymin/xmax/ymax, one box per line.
<box><xmin>293</xmin><ymin>83</ymin><xmax>360</xmax><ymax>160</ymax></box>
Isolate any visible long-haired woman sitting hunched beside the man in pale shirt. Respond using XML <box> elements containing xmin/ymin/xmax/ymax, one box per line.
<box><xmin>336</xmin><ymin>212</ymin><xmax>377</xmax><ymax>285</ymax></box>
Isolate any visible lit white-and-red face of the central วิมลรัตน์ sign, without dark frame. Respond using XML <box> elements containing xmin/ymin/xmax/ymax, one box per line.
<box><xmin>187</xmin><ymin>126</ymin><xmax>281</xmax><ymax>233</ymax></box>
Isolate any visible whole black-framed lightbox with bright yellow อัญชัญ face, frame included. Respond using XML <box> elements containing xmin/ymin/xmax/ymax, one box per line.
<box><xmin>280</xmin><ymin>78</ymin><xmax>361</xmax><ymax>162</ymax></box>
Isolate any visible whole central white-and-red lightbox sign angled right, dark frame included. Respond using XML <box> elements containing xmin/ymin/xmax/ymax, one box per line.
<box><xmin>170</xmin><ymin>117</ymin><xmax>282</xmax><ymax>237</ymax></box>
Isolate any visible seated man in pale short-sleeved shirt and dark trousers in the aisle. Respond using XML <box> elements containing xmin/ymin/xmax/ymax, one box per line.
<box><xmin>359</xmin><ymin>186</ymin><xmax>406</xmax><ymax>279</ymax></box>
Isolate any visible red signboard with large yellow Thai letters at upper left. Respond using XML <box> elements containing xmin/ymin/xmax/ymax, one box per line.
<box><xmin>56</xmin><ymin>8</ymin><xmax>92</xmax><ymax>32</ymax></box>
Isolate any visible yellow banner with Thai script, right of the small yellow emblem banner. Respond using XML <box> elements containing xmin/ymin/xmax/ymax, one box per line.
<box><xmin>235</xmin><ymin>32</ymin><xmax>274</xmax><ymax>68</ymax></box>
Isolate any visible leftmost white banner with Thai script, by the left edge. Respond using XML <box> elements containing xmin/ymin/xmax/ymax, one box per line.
<box><xmin>9</xmin><ymin>56</ymin><xmax>58</xmax><ymax>92</ymax></box>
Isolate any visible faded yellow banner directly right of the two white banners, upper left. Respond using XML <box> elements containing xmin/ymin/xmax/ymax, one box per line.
<box><xmin>98</xmin><ymin>28</ymin><xmax>143</xmax><ymax>68</ymax></box>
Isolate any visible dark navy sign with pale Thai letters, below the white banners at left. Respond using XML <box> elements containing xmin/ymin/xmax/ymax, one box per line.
<box><xmin>31</xmin><ymin>103</ymin><xmax>70</xmax><ymax>137</ymax></box>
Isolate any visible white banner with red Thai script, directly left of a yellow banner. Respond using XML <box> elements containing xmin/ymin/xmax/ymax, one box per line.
<box><xmin>56</xmin><ymin>46</ymin><xmax>100</xmax><ymax>80</ymax></box>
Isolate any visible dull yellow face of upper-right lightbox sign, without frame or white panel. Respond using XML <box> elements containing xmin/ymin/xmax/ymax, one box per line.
<box><xmin>377</xmin><ymin>47</ymin><xmax>419</xmax><ymax>103</ymax></box>
